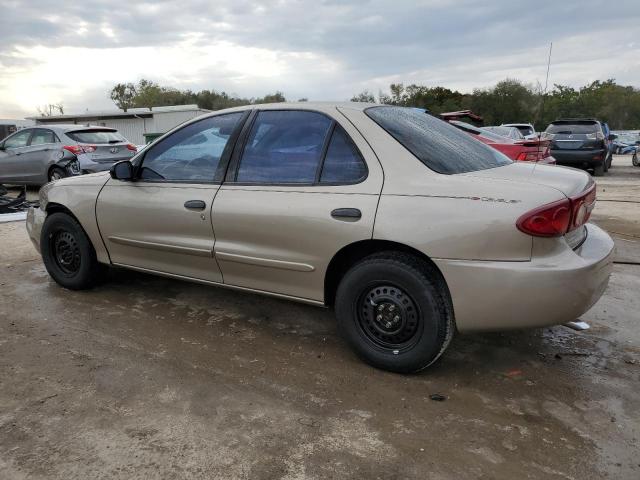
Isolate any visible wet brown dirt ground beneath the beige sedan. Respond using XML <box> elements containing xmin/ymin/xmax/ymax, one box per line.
<box><xmin>0</xmin><ymin>157</ymin><xmax>640</xmax><ymax>480</ymax></box>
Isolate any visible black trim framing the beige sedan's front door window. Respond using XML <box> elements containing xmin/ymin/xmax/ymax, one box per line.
<box><xmin>133</xmin><ymin>110</ymin><xmax>251</xmax><ymax>185</ymax></box>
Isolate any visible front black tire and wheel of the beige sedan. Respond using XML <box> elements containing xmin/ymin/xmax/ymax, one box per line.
<box><xmin>40</xmin><ymin>213</ymin><xmax>106</xmax><ymax>290</ymax></box>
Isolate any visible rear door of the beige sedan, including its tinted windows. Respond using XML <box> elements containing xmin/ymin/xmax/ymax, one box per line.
<box><xmin>213</xmin><ymin>109</ymin><xmax>382</xmax><ymax>302</ymax></box>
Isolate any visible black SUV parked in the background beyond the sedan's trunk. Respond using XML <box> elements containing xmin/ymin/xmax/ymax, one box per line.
<box><xmin>545</xmin><ymin>118</ymin><xmax>613</xmax><ymax>176</ymax></box>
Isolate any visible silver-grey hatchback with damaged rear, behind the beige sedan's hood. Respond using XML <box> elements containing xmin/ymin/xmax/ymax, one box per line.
<box><xmin>0</xmin><ymin>125</ymin><xmax>136</xmax><ymax>185</ymax></box>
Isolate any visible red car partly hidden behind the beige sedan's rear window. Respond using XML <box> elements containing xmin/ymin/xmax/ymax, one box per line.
<box><xmin>450</xmin><ymin>120</ymin><xmax>556</xmax><ymax>165</ymax></box>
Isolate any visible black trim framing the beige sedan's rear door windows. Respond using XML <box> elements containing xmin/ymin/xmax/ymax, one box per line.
<box><xmin>223</xmin><ymin>108</ymin><xmax>369</xmax><ymax>187</ymax></box>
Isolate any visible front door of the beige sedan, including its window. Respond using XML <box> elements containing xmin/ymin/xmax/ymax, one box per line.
<box><xmin>96</xmin><ymin>112</ymin><xmax>248</xmax><ymax>283</ymax></box>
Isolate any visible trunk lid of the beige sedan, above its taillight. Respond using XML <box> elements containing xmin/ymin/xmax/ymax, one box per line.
<box><xmin>462</xmin><ymin>162</ymin><xmax>593</xmax><ymax>197</ymax></box>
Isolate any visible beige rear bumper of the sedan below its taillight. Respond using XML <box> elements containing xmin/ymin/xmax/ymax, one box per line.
<box><xmin>434</xmin><ymin>224</ymin><xmax>614</xmax><ymax>332</ymax></box>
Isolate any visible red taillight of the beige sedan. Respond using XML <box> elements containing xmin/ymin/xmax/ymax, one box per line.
<box><xmin>516</xmin><ymin>185</ymin><xmax>596</xmax><ymax>237</ymax></box>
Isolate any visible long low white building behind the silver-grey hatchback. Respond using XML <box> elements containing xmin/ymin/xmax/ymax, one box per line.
<box><xmin>32</xmin><ymin>105</ymin><xmax>209</xmax><ymax>145</ymax></box>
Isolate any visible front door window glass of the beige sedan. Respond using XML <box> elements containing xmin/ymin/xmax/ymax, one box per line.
<box><xmin>140</xmin><ymin>112</ymin><xmax>243</xmax><ymax>182</ymax></box>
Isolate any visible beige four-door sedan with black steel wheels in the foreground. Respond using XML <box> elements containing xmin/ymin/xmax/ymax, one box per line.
<box><xmin>27</xmin><ymin>103</ymin><xmax>613</xmax><ymax>372</ymax></box>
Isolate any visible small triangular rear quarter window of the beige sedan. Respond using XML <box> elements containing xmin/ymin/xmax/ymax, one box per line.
<box><xmin>320</xmin><ymin>125</ymin><xmax>367</xmax><ymax>183</ymax></box>
